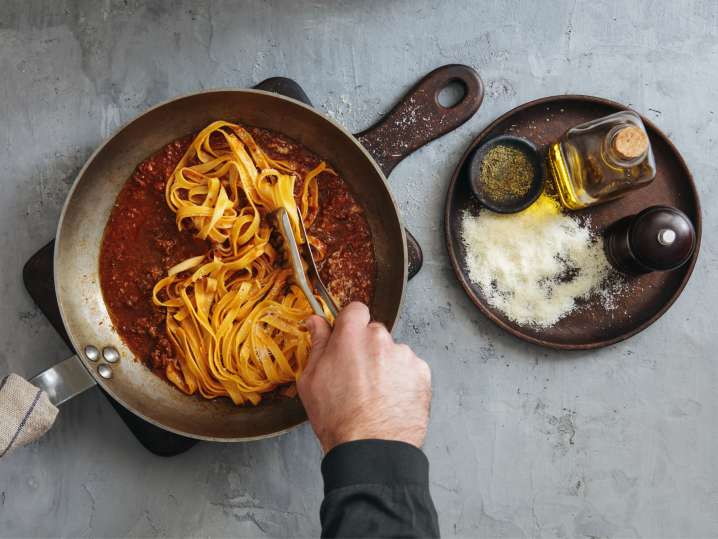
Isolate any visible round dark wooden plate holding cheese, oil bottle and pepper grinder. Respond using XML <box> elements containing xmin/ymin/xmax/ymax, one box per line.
<box><xmin>444</xmin><ymin>95</ymin><xmax>701</xmax><ymax>350</ymax></box>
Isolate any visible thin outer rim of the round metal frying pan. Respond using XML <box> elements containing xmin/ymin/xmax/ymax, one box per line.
<box><xmin>53</xmin><ymin>87</ymin><xmax>408</xmax><ymax>443</ymax></box>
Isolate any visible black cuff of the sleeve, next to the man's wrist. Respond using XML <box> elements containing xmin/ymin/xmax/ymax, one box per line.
<box><xmin>322</xmin><ymin>440</ymin><xmax>429</xmax><ymax>495</ymax></box>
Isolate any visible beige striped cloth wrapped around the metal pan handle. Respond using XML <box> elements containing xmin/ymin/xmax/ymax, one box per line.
<box><xmin>0</xmin><ymin>374</ymin><xmax>57</xmax><ymax>458</ymax></box>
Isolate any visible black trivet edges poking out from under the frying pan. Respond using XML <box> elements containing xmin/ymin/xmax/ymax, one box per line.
<box><xmin>22</xmin><ymin>77</ymin><xmax>312</xmax><ymax>457</ymax></box>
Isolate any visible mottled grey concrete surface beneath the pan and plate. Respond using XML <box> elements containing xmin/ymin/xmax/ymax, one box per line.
<box><xmin>0</xmin><ymin>0</ymin><xmax>718</xmax><ymax>537</ymax></box>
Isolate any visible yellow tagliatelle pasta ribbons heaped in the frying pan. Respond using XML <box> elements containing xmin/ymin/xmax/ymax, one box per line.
<box><xmin>152</xmin><ymin>121</ymin><xmax>331</xmax><ymax>404</ymax></box>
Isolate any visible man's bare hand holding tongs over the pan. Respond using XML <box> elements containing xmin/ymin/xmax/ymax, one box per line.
<box><xmin>298</xmin><ymin>303</ymin><xmax>431</xmax><ymax>453</ymax></box>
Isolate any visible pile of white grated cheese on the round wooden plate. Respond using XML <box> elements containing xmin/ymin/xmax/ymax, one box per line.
<box><xmin>462</xmin><ymin>195</ymin><xmax>614</xmax><ymax>327</ymax></box>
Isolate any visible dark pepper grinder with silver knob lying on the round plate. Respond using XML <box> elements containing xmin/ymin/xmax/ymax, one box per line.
<box><xmin>604</xmin><ymin>206</ymin><xmax>696</xmax><ymax>275</ymax></box>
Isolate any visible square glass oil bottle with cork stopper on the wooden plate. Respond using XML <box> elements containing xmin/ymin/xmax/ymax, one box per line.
<box><xmin>548</xmin><ymin>111</ymin><xmax>656</xmax><ymax>210</ymax></box>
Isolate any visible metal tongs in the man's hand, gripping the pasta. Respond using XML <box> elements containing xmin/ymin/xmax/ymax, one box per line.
<box><xmin>274</xmin><ymin>208</ymin><xmax>339</xmax><ymax>320</ymax></box>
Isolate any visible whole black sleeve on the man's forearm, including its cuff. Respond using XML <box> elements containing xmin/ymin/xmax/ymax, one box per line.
<box><xmin>320</xmin><ymin>440</ymin><xmax>439</xmax><ymax>537</ymax></box>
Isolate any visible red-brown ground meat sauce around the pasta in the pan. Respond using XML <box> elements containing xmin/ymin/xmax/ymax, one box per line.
<box><xmin>100</xmin><ymin>128</ymin><xmax>376</xmax><ymax>374</ymax></box>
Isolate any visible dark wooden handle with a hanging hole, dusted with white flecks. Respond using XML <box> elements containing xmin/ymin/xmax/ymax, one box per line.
<box><xmin>355</xmin><ymin>64</ymin><xmax>484</xmax><ymax>176</ymax></box>
